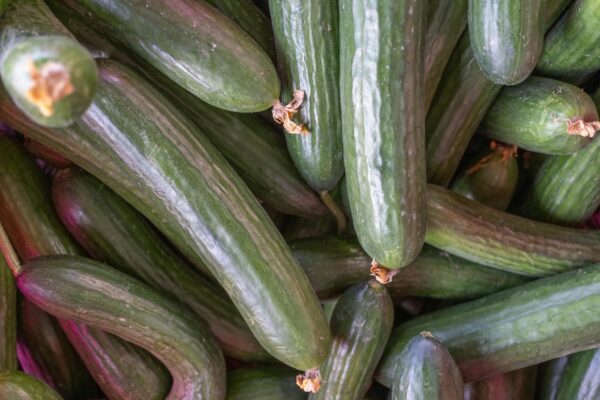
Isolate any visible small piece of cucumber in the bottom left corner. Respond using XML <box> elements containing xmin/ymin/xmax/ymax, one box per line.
<box><xmin>0</xmin><ymin>371</ymin><xmax>62</xmax><ymax>400</ymax></box>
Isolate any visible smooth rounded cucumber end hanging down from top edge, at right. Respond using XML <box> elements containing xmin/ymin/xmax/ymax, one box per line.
<box><xmin>469</xmin><ymin>0</ymin><xmax>544</xmax><ymax>85</ymax></box>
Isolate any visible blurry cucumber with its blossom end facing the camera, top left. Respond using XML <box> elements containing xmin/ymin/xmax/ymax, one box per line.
<box><xmin>0</xmin><ymin>0</ymin><xmax>98</xmax><ymax>127</ymax></box>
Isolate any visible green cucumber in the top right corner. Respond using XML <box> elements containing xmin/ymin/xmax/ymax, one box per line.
<box><xmin>536</xmin><ymin>0</ymin><xmax>600</xmax><ymax>85</ymax></box>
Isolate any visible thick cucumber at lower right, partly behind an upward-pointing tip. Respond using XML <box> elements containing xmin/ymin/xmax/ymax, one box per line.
<box><xmin>375</xmin><ymin>265</ymin><xmax>600</xmax><ymax>386</ymax></box>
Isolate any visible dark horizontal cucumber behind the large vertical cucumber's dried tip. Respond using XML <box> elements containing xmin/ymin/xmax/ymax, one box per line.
<box><xmin>290</xmin><ymin>237</ymin><xmax>527</xmax><ymax>300</ymax></box>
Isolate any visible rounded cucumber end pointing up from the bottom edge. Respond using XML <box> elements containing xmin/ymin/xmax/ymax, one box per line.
<box><xmin>391</xmin><ymin>332</ymin><xmax>463</xmax><ymax>400</ymax></box>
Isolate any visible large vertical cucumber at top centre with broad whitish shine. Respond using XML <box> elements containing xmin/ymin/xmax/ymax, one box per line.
<box><xmin>340</xmin><ymin>0</ymin><xmax>426</xmax><ymax>269</ymax></box>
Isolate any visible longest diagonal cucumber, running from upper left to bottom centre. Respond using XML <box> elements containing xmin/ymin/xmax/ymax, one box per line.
<box><xmin>0</xmin><ymin>60</ymin><xmax>330</xmax><ymax>370</ymax></box>
